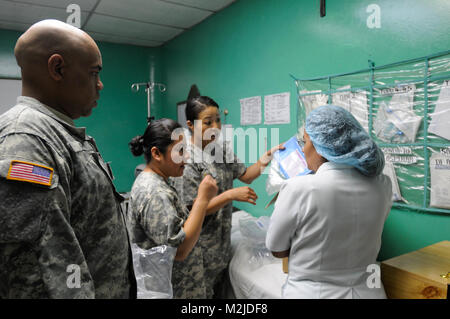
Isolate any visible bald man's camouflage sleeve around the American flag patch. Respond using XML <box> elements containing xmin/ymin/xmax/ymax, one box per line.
<box><xmin>0</xmin><ymin>134</ymin><xmax>95</xmax><ymax>298</ymax></box>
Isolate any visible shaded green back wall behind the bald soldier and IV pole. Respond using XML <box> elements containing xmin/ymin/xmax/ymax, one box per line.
<box><xmin>0</xmin><ymin>30</ymin><xmax>161</xmax><ymax>192</ymax></box>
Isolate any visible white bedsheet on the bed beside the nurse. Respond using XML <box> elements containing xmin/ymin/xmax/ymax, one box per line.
<box><xmin>229</xmin><ymin>211</ymin><xmax>287</xmax><ymax>299</ymax></box>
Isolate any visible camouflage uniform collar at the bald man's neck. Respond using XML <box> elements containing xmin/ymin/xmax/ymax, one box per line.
<box><xmin>17</xmin><ymin>96</ymin><xmax>86</xmax><ymax>140</ymax></box>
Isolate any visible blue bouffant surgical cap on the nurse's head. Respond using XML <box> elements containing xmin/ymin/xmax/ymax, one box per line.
<box><xmin>305</xmin><ymin>105</ymin><xmax>384</xmax><ymax>176</ymax></box>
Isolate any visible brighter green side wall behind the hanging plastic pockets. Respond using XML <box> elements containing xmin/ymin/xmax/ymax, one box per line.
<box><xmin>162</xmin><ymin>0</ymin><xmax>450</xmax><ymax>260</ymax></box>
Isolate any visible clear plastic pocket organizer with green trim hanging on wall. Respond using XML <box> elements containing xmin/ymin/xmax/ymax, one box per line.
<box><xmin>294</xmin><ymin>51</ymin><xmax>450</xmax><ymax>213</ymax></box>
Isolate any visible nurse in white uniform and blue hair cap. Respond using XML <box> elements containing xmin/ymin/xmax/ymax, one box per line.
<box><xmin>266</xmin><ymin>105</ymin><xmax>392</xmax><ymax>299</ymax></box>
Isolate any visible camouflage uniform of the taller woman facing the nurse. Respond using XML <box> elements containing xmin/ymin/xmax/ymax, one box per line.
<box><xmin>171</xmin><ymin>138</ymin><xmax>246</xmax><ymax>298</ymax></box>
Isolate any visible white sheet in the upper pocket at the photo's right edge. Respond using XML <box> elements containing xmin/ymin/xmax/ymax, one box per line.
<box><xmin>428</xmin><ymin>80</ymin><xmax>450</xmax><ymax>140</ymax></box>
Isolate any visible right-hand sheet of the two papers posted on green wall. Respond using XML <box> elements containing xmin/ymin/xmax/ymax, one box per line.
<box><xmin>264</xmin><ymin>92</ymin><xmax>291</xmax><ymax>124</ymax></box>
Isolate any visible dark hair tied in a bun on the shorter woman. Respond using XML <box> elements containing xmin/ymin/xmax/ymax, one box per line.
<box><xmin>128</xmin><ymin>119</ymin><xmax>181</xmax><ymax>163</ymax></box>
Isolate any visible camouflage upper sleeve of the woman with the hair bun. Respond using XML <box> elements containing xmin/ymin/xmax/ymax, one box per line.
<box><xmin>141</xmin><ymin>192</ymin><xmax>186</xmax><ymax>247</ymax></box>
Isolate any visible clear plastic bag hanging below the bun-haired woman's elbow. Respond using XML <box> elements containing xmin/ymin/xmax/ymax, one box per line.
<box><xmin>131</xmin><ymin>244</ymin><xmax>177</xmax><ymax>299</ymax></box>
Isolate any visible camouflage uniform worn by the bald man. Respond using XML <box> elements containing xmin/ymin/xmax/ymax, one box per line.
<box><xmin>0</xmin><ymin>97</ymin><xmax>135</xmax><ymax>298</ymax></box>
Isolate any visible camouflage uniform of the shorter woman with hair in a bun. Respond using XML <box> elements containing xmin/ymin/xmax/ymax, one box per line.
<box><xmin>128</xmin><ymin>172</ymin><xmax>206</xmax><ymax>299</ymax></box>
